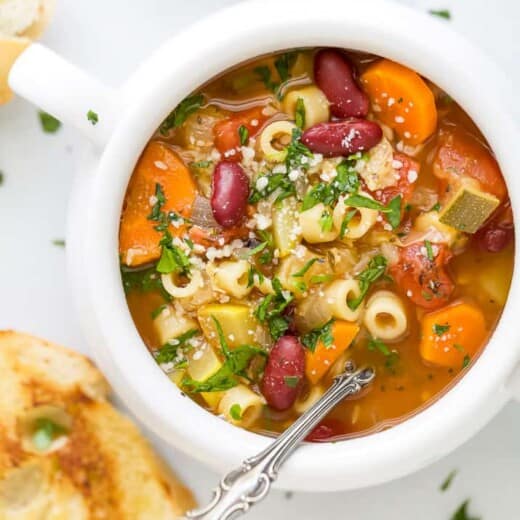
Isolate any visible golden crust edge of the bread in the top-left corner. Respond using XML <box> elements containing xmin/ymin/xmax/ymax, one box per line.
<box><xmin>0</xmin><ymin>0</ymin><xmax>55</xmax><ymax>105</ymax></box>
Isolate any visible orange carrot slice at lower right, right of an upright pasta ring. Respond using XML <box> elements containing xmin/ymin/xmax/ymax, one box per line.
<box><xmin>419</xmin><ymin>302</ymin><xmax>488</xmax><ymax>368</ymax></box>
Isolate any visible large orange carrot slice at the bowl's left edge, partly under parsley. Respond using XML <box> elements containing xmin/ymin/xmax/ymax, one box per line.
<box><xmin>119</xmin><ymin>141</ymin><xmax>196</xmax><ymax>266</ymax></box>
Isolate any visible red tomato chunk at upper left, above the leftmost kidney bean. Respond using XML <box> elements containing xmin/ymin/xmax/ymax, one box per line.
<box><xmin>213</xmin><ymin>107</ymin><xmax>267</xmax><ymax>161</ymax></box>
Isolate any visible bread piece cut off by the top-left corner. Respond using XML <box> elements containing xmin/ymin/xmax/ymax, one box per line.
<box><xmin>0</xmin><ymin>0</ymin><xmax>55</xmax><ymax>105</ymax></box>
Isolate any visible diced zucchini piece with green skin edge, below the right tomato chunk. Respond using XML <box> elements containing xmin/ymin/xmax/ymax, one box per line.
<box><xmin>439</xmin><ymin>186</ymin><xmax>500</xmax><ymax>233</ymax></box>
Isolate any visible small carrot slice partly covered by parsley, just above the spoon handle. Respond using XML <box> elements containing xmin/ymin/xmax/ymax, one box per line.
<box><xmin>305</xmin><ymin>320</ymin><xmax>359</xmax><ymax>385</ymax></box>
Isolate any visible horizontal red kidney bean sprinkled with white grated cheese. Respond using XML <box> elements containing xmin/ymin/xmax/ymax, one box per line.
<box><xmin>302</xmin><ymin>119</ymin><xmax>383</xmax><ymax>157</ymax></box>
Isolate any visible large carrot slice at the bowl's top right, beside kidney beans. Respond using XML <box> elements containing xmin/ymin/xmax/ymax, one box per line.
<box><xmin>361</xmin><ymin>60</ymin><xmax>437</xmax><ymax>145</ymax></box>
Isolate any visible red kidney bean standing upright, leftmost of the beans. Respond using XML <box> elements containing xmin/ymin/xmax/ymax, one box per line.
<box><xmin>211</xmin><ymin>161</ymin><xmax>249</xmax><ymax>228</ymax></box>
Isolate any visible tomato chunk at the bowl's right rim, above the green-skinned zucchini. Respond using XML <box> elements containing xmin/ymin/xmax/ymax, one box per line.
<box><xmin>433</xmin><ymin>127</ymin><xmax>507</xmax><ymax>201</ymax></box>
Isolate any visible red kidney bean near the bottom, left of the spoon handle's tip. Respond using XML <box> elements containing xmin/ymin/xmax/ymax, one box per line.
<box><xmin>261</xmin><ymin>336</ymin><xmax>305</xmax><ymax>410</ymax></box>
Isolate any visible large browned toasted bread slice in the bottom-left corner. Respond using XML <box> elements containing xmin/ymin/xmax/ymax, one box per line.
<box><xmin>0</xmin><ymin>331</ymin><xmax>194</xmax><ymax>520</ymax></box>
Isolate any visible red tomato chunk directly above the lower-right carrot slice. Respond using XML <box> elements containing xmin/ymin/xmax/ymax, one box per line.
<box><xmin>390</xmin><ymin>242</ymin><xmax>455</xmax><ymax>309</ymax></box>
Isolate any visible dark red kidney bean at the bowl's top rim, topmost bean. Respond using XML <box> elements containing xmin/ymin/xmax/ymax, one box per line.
<box><xmin>314</xmin><ymin>49</ymin><xmax>369</xmax><ymax>119</ymax></box>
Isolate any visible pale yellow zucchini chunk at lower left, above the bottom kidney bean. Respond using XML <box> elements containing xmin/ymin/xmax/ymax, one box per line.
<box><xmin>198</xmin><ymin>303</ymin><xmax>258</xmax><ymax>349</ymax></box>
